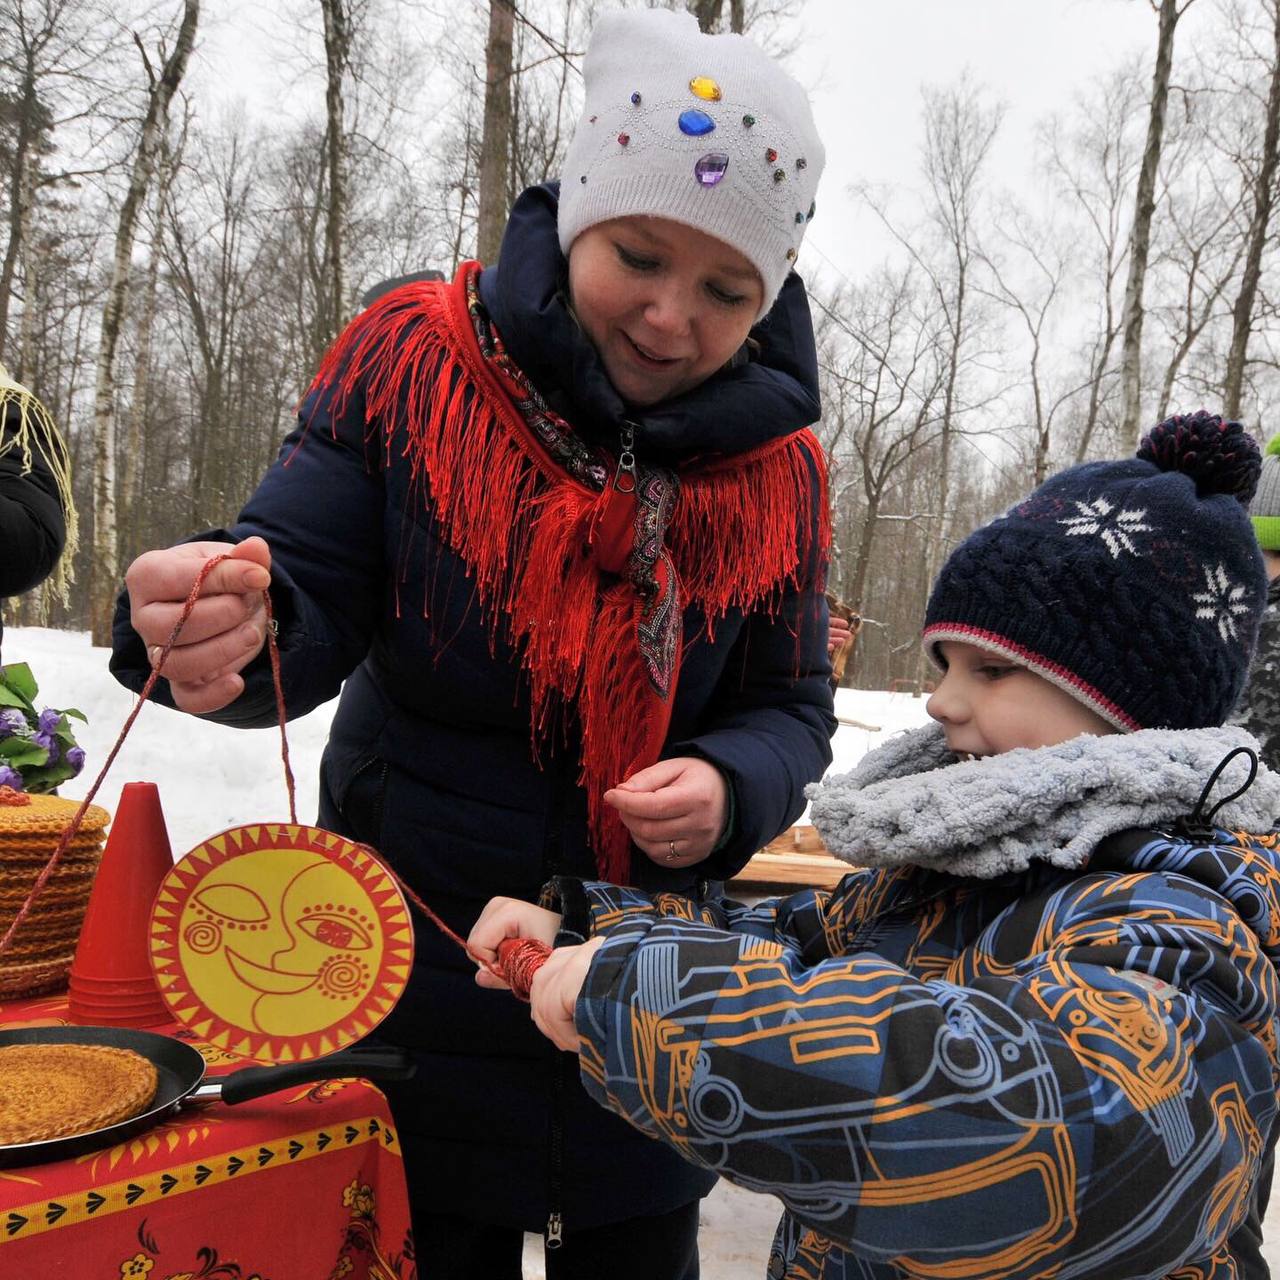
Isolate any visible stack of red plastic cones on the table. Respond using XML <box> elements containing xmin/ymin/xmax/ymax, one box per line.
<box><xmin>69</xmin><ymin>782</ymin><xmax>173</xmax><ymax>1025</ymax></box>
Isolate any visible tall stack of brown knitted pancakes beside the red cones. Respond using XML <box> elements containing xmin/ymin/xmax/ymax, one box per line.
<box><xmin>0</xmin><ymin>795</ymin><xmax>111</xmax><ymax>1000</ymax></box>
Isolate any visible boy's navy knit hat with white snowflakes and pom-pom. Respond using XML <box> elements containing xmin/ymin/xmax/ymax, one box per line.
<box><xmin>924</xmin><ymin>410</ymin><xmax>1267</xmax><ymax>730</ymax></box>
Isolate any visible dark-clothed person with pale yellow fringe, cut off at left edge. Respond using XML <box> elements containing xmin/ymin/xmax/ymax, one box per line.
<box><xmin>0</xmin><ymin>365</ymin><xmax>76</xmax><ymax>650</ymax></box>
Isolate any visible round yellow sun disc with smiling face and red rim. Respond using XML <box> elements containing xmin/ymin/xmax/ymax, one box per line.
<box><xmin>151</xmin><ymin>823</ymin><xmax>413</xmax><ymax>1062</ymax></box>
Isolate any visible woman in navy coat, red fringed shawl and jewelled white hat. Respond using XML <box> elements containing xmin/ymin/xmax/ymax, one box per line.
<box><xmin>113</xmin><ymin>12</ymin><xmax>835</xmax><ymax>1280</ymax></box>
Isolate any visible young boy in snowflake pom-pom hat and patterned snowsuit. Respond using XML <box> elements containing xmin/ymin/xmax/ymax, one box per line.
<box><xmin>471</xmin><ymin>413</ymin><xmax>1280</xmax><ymax>1280</ymax></box>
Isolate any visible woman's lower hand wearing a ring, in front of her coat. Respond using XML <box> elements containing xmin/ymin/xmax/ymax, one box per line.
<box><xmin>604</xmin><ymin>755</ymin><xmax>728</xmax><ymax>867</ymax></box>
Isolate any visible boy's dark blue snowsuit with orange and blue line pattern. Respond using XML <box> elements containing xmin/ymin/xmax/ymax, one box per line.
<box><xmin>557</xmin><ymin>773</ymin><xmax>1280</xmax><ymax>1280</ymax></box>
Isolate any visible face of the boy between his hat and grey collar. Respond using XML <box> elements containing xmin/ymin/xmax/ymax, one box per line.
<box><xmin>927</xmin><ymin>640</ymin><xmax>1116</xmax><ymax>755</ymax></box>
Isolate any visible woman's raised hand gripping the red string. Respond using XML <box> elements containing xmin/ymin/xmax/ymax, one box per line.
<box><xmin>124</xmin><ymin>538</ymin><xmax>271</xmax><ymax>714</ymax></box>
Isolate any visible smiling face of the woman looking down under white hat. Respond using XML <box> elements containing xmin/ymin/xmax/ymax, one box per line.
<box><xmin>568</xmin><ymin>216</ymin><xmax>764</xmax><ymax>404</ymax></box>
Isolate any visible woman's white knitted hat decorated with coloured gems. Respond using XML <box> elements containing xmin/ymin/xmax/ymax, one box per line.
<box><xmin>559</xmin><ymin>9</ymin><xmax>826</xmax><ymax>316</ymax></box>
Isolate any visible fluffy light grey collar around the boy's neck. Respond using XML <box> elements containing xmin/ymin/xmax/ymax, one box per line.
<box><xmin>806</xmin><ymin>724</ymin><xmax>1280</xmax><ymax>879</ymax></box>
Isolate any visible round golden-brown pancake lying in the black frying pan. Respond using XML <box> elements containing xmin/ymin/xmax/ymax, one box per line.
<box><xmin>0</xmin><ymin>1044</ymin><xmax>159</xmax><ymax>1146</ymax></box>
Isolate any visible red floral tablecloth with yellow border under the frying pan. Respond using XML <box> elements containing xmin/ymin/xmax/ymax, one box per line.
<box><xmin>0</xmin><ymin>996</ymin><xmax>417</xmax><ymax>1280</ymax></box>
